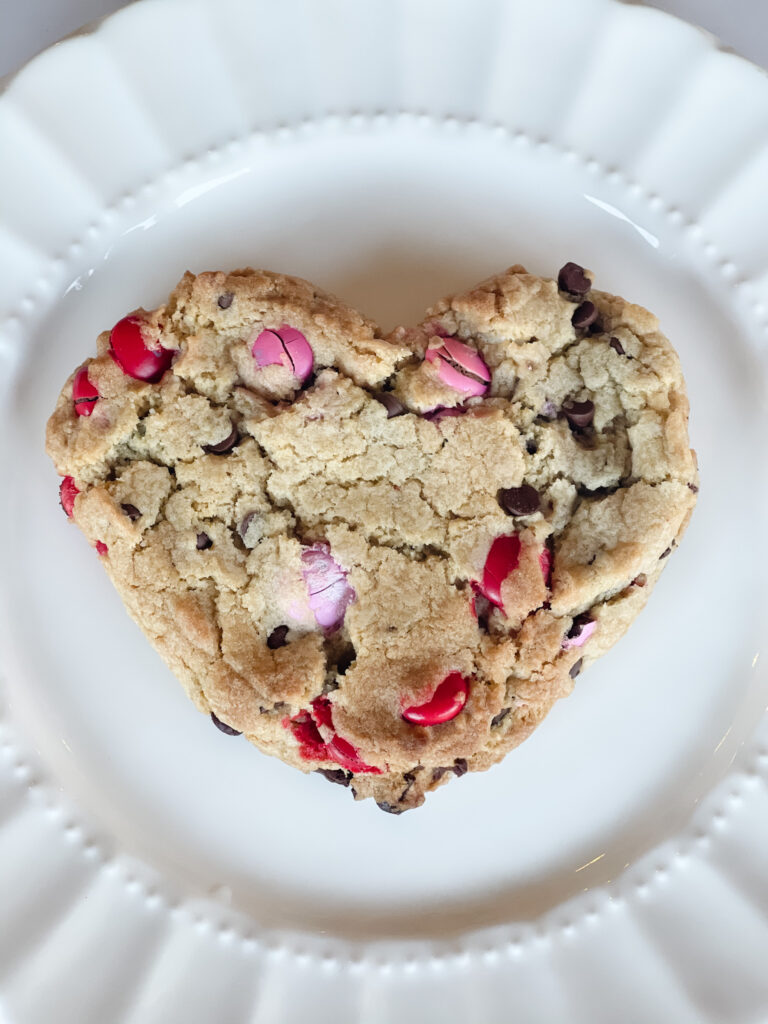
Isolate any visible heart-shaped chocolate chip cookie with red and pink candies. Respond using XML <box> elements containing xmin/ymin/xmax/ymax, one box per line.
<box><xmin>47</xmin><ymin>263</ymin><xmax>697</xmax><ymax>813</ymax></box>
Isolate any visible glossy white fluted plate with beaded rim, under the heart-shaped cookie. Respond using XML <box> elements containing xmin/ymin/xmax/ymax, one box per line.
<box><xmin>0</xmin><ymin>0</ymin><xmax>768</xmax><ymax>1024</ymax></box>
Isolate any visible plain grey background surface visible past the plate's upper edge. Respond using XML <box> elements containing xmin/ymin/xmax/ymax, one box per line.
<box><xmin>0</xmin><ymin>0</ymin><xmax>768</xmax><ymax>76</ymax></box>
